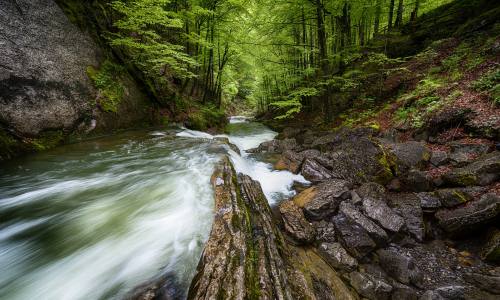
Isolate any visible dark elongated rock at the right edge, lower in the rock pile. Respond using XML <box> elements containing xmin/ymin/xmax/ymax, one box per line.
<box><xmin>436</xmin><ymin>193</ymin><xmax>500</xmax><ymax>233</ymax></box>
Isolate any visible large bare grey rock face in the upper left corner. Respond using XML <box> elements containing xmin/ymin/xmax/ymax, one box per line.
<box><xmin>0</xmin><ymin>0</ymin><xmax>99</xmax><ymax>136</ymax></box>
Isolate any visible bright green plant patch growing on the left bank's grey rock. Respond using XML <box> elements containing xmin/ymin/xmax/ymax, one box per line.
<box><xmin>87</xmin><ymin>60</ymin><xmax>125</xmax><ymax>112</ymax></box>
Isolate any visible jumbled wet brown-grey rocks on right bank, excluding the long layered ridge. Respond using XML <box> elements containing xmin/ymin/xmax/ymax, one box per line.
<box><xmin>248</xmin><ymin>128</ymin><xmax>500</xmax><ymax>299</ymax></box>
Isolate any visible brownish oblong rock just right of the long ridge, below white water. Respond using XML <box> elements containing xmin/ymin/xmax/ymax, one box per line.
<box><xmin>279</xmin><ymin>201</ymin><xmax>314</xmax><ymax>243</ymax></box>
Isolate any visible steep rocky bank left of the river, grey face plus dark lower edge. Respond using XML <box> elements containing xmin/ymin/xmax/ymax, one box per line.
<box><xmin>0</xmin><ymin>0</ymin><xmax>151</xmax><ymax>160</ymax></box>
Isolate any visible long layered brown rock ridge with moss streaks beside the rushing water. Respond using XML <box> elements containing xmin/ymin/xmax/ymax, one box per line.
<box><xmin>188</xmin><ymin>157</ymin><xmax>354</xmax><ymax>299</ymax></box>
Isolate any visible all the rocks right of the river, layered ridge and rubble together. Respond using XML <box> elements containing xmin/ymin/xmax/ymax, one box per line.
<box><xmin>155</xmin><ymin>123</ymin><xmax>500</xmax><ymax>299</ymax></box>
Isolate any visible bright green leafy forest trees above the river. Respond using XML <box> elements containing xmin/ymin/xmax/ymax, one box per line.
<box><xmin>107</xmin><ymin>0</ymin><xmax>450</xmax><ymax>118</ymax></box>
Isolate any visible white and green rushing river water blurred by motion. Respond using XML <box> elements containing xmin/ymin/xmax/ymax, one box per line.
<box><xmin>0</xmin><ymin>117</ymin><xmax>305</xmax><ymax>300</ymax></box>
